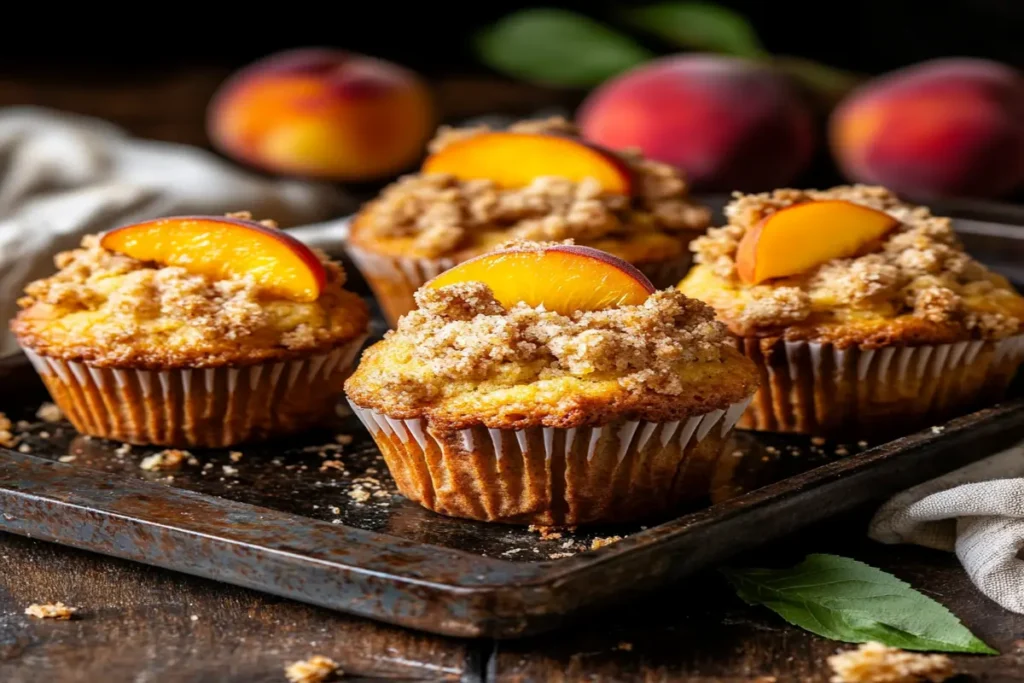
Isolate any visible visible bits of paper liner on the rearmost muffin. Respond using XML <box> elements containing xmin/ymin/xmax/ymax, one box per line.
<box><xmin>347</xmin><ymin>244</ymin><xmax>692</xmax><ymax>328</ymax></box>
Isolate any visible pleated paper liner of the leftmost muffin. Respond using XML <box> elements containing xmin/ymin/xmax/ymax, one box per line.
<box><xmin>24</xmin><ymin>337</ymin><xmax>366</xmax><ymax>447</ymax></box>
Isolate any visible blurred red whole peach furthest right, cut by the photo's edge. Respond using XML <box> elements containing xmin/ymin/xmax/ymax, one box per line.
<box><xmin>829</xmin><ymin>58</ymin><xmax>1024</xmax><ymax>199</ymax></box>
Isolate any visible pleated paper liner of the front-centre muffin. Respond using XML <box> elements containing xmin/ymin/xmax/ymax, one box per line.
<box><xmin>349</xmin><ymin>399</ymin><xmax>750</xmax><ymax>525</ymax></box>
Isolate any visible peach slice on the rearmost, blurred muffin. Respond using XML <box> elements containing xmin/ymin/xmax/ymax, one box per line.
<box><xmin>423</xmin><ymin>132</ymin><xmax>632</xmax><ymax>195</ymax></box>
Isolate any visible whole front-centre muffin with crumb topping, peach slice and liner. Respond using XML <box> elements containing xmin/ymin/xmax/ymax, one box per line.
<box><xmin>345</xmin><ymin>244</ymin><xmax>757</xmax><ymax>525</ymax></box>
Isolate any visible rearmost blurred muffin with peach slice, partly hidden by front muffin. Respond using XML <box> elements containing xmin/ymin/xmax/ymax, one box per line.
<box><xmin>349</xmin><ymin>119</ymin><xmax>710</xmax><ymax>326</ymax></box>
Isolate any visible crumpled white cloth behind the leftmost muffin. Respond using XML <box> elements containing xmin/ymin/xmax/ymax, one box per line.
<box><xmin>0</xmin><ymin>108</ymin><xmax>350</xmax><ymax>356</ymax></box>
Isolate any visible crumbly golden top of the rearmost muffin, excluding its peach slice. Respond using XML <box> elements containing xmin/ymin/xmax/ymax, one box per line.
<box><xmin>352</xmin><ymin>118</ymin><xmax>710</xmax><ymax>262</ymax></box>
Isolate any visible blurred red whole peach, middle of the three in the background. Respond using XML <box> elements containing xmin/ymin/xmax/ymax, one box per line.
<box><xmin>578</xmin><ymin>54</ymin><xmax>814</xmax><ymax>190</ymax></box>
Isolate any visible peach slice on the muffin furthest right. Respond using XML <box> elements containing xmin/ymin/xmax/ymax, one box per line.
<box><xmin>736</xmin><ymin>200</ymin><xmax>899</xmax><ymax>285</ymax></box>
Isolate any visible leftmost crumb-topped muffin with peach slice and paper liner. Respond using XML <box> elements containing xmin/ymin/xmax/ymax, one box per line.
<box><xmin>11</xmin><ymin>214</ymin><xmax>369</xmax><ymax>446</ymax></box>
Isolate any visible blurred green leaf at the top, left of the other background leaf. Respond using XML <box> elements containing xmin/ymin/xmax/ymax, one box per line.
<box><xmin>475</xmin><ymin>9</ymin><xmax>653</xmax><ymax>87</ymax></box>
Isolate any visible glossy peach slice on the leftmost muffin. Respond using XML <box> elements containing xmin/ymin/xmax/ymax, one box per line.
<box><xmin>99</xmin><ymin>216</ymin><xmax>327</xmax><ymax>302</ymax></box>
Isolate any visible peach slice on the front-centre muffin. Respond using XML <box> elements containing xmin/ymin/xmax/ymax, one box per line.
<box><xmin>426</xmin><ymin>245</ymin><xmax>654</xmax><ymax>315</ymax></box>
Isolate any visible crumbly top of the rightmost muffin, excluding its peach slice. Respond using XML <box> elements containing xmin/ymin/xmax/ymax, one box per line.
<box><xmin>691</xmin><ymin>185</ymin><xmax>1024</xmax><ymax>339</ymax></box>
